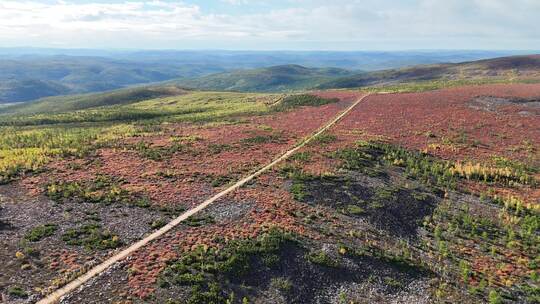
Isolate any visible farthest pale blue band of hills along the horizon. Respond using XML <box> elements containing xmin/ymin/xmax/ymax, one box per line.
<box><xmin>0</xmin><ymin>48</ymin><xmax>530</xmax><ymax>71</ymax></box>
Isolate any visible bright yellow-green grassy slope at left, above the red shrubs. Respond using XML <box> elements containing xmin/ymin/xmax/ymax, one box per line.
<box><xmin>0</xmin><ymin>92</ymin><xmax>275</xmax><ymax>126</ymax></box>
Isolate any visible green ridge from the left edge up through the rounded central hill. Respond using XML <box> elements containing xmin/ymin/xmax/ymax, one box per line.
<box><xmin>0</xmin><ymin>65</ymin><xmax>350</xmax><ymax>114</ymax></box>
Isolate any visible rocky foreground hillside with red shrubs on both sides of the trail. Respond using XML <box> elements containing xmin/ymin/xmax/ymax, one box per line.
<box><xmin>0</xmin><ymin>85</ymin><xmax>540</xmax><ymax>304</ymax></box>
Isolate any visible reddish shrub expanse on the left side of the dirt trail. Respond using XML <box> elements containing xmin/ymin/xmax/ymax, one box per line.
<box><xmin>22</xmin><ymin>93</ymin><xmax>358</xmax><ymax>207</ymax></box>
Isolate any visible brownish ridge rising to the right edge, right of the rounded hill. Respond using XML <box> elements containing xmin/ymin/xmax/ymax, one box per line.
<box><xmin>318</xmin><ymin>55</ymin><xmax>540</xmax><ymax>89</ymax></box>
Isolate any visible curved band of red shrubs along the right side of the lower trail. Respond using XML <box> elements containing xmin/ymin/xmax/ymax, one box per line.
<box><xmin>129</xmin><ymin>175</ymin><xmax>317</xmax><ymax>298</ymax></box>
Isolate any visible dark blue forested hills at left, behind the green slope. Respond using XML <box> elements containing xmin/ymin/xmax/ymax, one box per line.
<box><xmin>0</xmin><ymin>56</ymin><xmax>223</xmax><ymax>104</ymax></box>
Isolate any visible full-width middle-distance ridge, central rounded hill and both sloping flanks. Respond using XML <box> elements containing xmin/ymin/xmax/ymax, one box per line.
<box><xmin>0</xmin><ymin>55</ymin><xmax>540</xmax><ymax>114</ymax></box>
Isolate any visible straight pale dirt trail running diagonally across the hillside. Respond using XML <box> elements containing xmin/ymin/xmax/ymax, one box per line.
<box><xmin>37</xmin><ymin>94</ymin><xmax>370</xmax><ymax>304</ymax></box>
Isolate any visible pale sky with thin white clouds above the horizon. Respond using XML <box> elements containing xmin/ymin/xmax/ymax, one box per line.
<box><xmin>0</xmin><ymin>0</ymin><xmax>540</xmax><ymax>50</ymax></box>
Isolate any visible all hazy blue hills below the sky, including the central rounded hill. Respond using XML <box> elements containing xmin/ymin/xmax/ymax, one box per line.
<box><xmin>0</xmin><ymin>48</ymin><xmax>532</xmax><ymax>104</ymax></box>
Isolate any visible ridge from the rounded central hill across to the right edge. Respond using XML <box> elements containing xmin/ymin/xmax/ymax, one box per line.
<box><xmin>176</xmin><ymin>55</ymin><xmax>540</xmax><ymax>92</ymax></box>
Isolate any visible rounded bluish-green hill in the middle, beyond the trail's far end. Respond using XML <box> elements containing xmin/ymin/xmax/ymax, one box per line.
<box><xmin>178</xmin><ymin>65</ymin><xmax>352</xmax><ymax>92</ymax></box>
